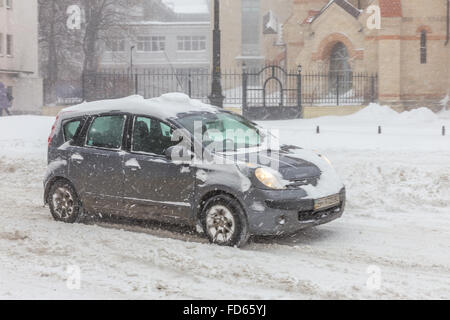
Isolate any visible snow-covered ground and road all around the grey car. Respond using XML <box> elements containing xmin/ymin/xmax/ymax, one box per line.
<box><xmin>0</xmin><ymin>107</ymin><xmax>450</xmax><ymax>299</ymax></box>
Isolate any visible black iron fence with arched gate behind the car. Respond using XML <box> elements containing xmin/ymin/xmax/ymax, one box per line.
<box><xmin>81</xmin><ymin>66</ymin><xmax>378</xmax><ymax>108</ymax></box>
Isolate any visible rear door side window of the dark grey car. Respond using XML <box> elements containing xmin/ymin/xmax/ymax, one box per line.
<box><xmin>86</xmin><ymin>115</ymin><xmax>125</xmax><ymax>149</ymax></box>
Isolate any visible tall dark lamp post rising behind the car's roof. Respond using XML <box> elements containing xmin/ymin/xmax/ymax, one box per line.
<box><xmin>209</xmin><ymin>0</ymin><xmax>225</xmax><ymax>108</ymax></box>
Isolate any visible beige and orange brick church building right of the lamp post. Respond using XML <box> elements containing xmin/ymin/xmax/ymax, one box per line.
<box><xmin>216</xmin><ymin>0</ymin><xmax>450</xmax><ymax>110</ymax></box>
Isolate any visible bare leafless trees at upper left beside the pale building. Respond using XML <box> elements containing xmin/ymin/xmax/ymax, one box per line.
<box><xmin>39</xmin><ymin>0</ymin><xmax>173</xmax><ymax>102</ymax></box>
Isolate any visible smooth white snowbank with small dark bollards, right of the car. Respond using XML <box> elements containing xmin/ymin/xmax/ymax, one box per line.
<box><xmin>261</xmin><ymin>104</ymin><xmax>450</xmax><ymax>152</ymax></box>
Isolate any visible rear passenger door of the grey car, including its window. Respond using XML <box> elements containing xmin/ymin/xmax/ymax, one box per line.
<box><xmin>69</xmin><ymin>114</ymin><xmax>127</xmax><ymax>213</ymax></box>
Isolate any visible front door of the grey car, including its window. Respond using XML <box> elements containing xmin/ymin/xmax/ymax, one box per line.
<box><xmin>124</xmin><ymin>116</ymin><xmax>195</xmax><ymax>223</ymax></box>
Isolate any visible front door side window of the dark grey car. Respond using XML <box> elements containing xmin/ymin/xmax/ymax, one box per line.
<box><xmin>132</xmin><ymin>117</ymin><xmax>176</xmax><ymax>155</ymax></box>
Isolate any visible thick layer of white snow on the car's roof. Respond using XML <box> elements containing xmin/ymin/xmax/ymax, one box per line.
<box><xmin>61</xmin><ymin>93</ymin><xmax>220</xmax><ymax>119</ymax></box>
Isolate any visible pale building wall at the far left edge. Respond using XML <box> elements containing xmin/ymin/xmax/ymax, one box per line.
<box><xmin>0</xmin><ymin>0</ymin><xmax>43</xmax><ymax>114</ymax></box>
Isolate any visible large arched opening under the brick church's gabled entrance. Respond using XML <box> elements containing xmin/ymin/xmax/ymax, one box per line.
<box><xmin>330</xmin><ymin>42</ymin><xmax>353</xmax><ymax>94</ymax></box>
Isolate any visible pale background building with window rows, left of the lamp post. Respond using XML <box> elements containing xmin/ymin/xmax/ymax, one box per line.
<box><xmin>99</xmin><ymin>6</ymin><xmax>211</xmax><ymax>72</ymax></box>
